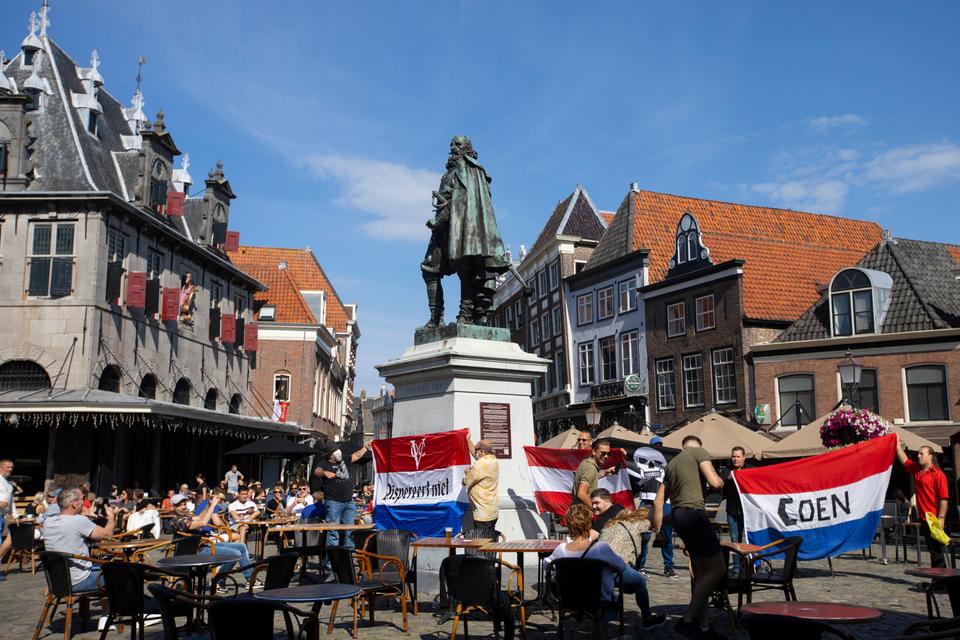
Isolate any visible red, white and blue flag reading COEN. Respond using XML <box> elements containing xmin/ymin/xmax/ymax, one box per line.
<box><xmin>733</xmin><ymin>435</ymin><xmax>897</xmax><ymax>560</ymax></box>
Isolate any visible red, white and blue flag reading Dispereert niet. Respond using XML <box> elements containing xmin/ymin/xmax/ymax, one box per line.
<box><xmin>372</xmin><ymin>429</ymin><xmax>471</xmax><ymax>536</ymax></box>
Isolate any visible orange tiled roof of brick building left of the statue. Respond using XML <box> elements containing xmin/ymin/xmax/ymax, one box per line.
<box><xmin>227</xmin><ymin>245</ymin><xmax>347</xmax><ymax>333</ymax></box>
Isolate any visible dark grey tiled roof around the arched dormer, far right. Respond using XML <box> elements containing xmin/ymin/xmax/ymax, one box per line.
<box><xmin>774</xmin><ymin>238</ymin><xmax>960</xmax><ymax>342</ymax></box>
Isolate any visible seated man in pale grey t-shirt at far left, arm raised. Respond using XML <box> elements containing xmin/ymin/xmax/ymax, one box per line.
<box><xmin>43</xmin><ymin>488</ymin><xmax>116</xmax><ymax>593</ymax></box>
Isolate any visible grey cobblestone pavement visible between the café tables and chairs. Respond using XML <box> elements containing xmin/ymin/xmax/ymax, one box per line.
<box><xmin>0</xmin><ymin>548</ymin><xmax>949</xmax><ymax>640</ymax></box>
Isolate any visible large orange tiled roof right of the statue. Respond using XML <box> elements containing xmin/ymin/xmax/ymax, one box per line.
<box><xmin>585</xmin><ymin>190</ymin><xmax>883</xmax><ymax>322</ymax></box>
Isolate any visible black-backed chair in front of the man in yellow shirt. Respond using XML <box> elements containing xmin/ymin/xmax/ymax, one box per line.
<box><xmin>440</xmin><ymin>555</ymin><xmax>514</xmax><ymax>640</ymax></box>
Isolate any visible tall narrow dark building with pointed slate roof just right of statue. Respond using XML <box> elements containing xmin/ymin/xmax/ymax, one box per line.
<box><xmin>494</xmin><ymin>185</ymin><xmax>609</xmax><ymax>441</ymax></box>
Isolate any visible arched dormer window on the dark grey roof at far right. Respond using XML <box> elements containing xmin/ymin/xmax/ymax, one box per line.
<box><xmin>830</xmin><ymin>269</ymin><xmax>893</xmax><ymax>337</ymax></box>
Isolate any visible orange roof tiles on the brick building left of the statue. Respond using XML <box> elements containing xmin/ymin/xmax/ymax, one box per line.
<box><xmin>227</xmin><ymin>246</ymin><xmax>347</xmax><ymax>332</ymax></box>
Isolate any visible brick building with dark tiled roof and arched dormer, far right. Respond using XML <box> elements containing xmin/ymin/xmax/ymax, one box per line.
<box><xmin>750</xmin><ymin>239</ymin><xmax>960</xmax><ymax>452</ymax></box>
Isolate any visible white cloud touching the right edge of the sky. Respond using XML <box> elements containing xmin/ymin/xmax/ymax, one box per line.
<box><xmin>862</xmin><ymin>140</ymin><xmax>960</xmax><ymax>195</ymax></box>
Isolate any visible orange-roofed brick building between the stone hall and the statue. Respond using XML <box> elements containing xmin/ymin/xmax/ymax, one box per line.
<box><xmin>229</xmin><ymin>246</ymin><xmax>360</xmax><ymax>440</ymax></box>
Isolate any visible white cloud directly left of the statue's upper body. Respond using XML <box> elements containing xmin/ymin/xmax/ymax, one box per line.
<box><xmin>302</xmin><ymin>154</ymin><xmax>440</xmax><ymax>240</ymax></box>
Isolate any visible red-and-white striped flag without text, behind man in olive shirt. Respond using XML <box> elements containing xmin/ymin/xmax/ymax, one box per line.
<box><xmin>523</xmin><ymin>447</ymin><xmax>634</xmax><ymax>516</ymax></box>
